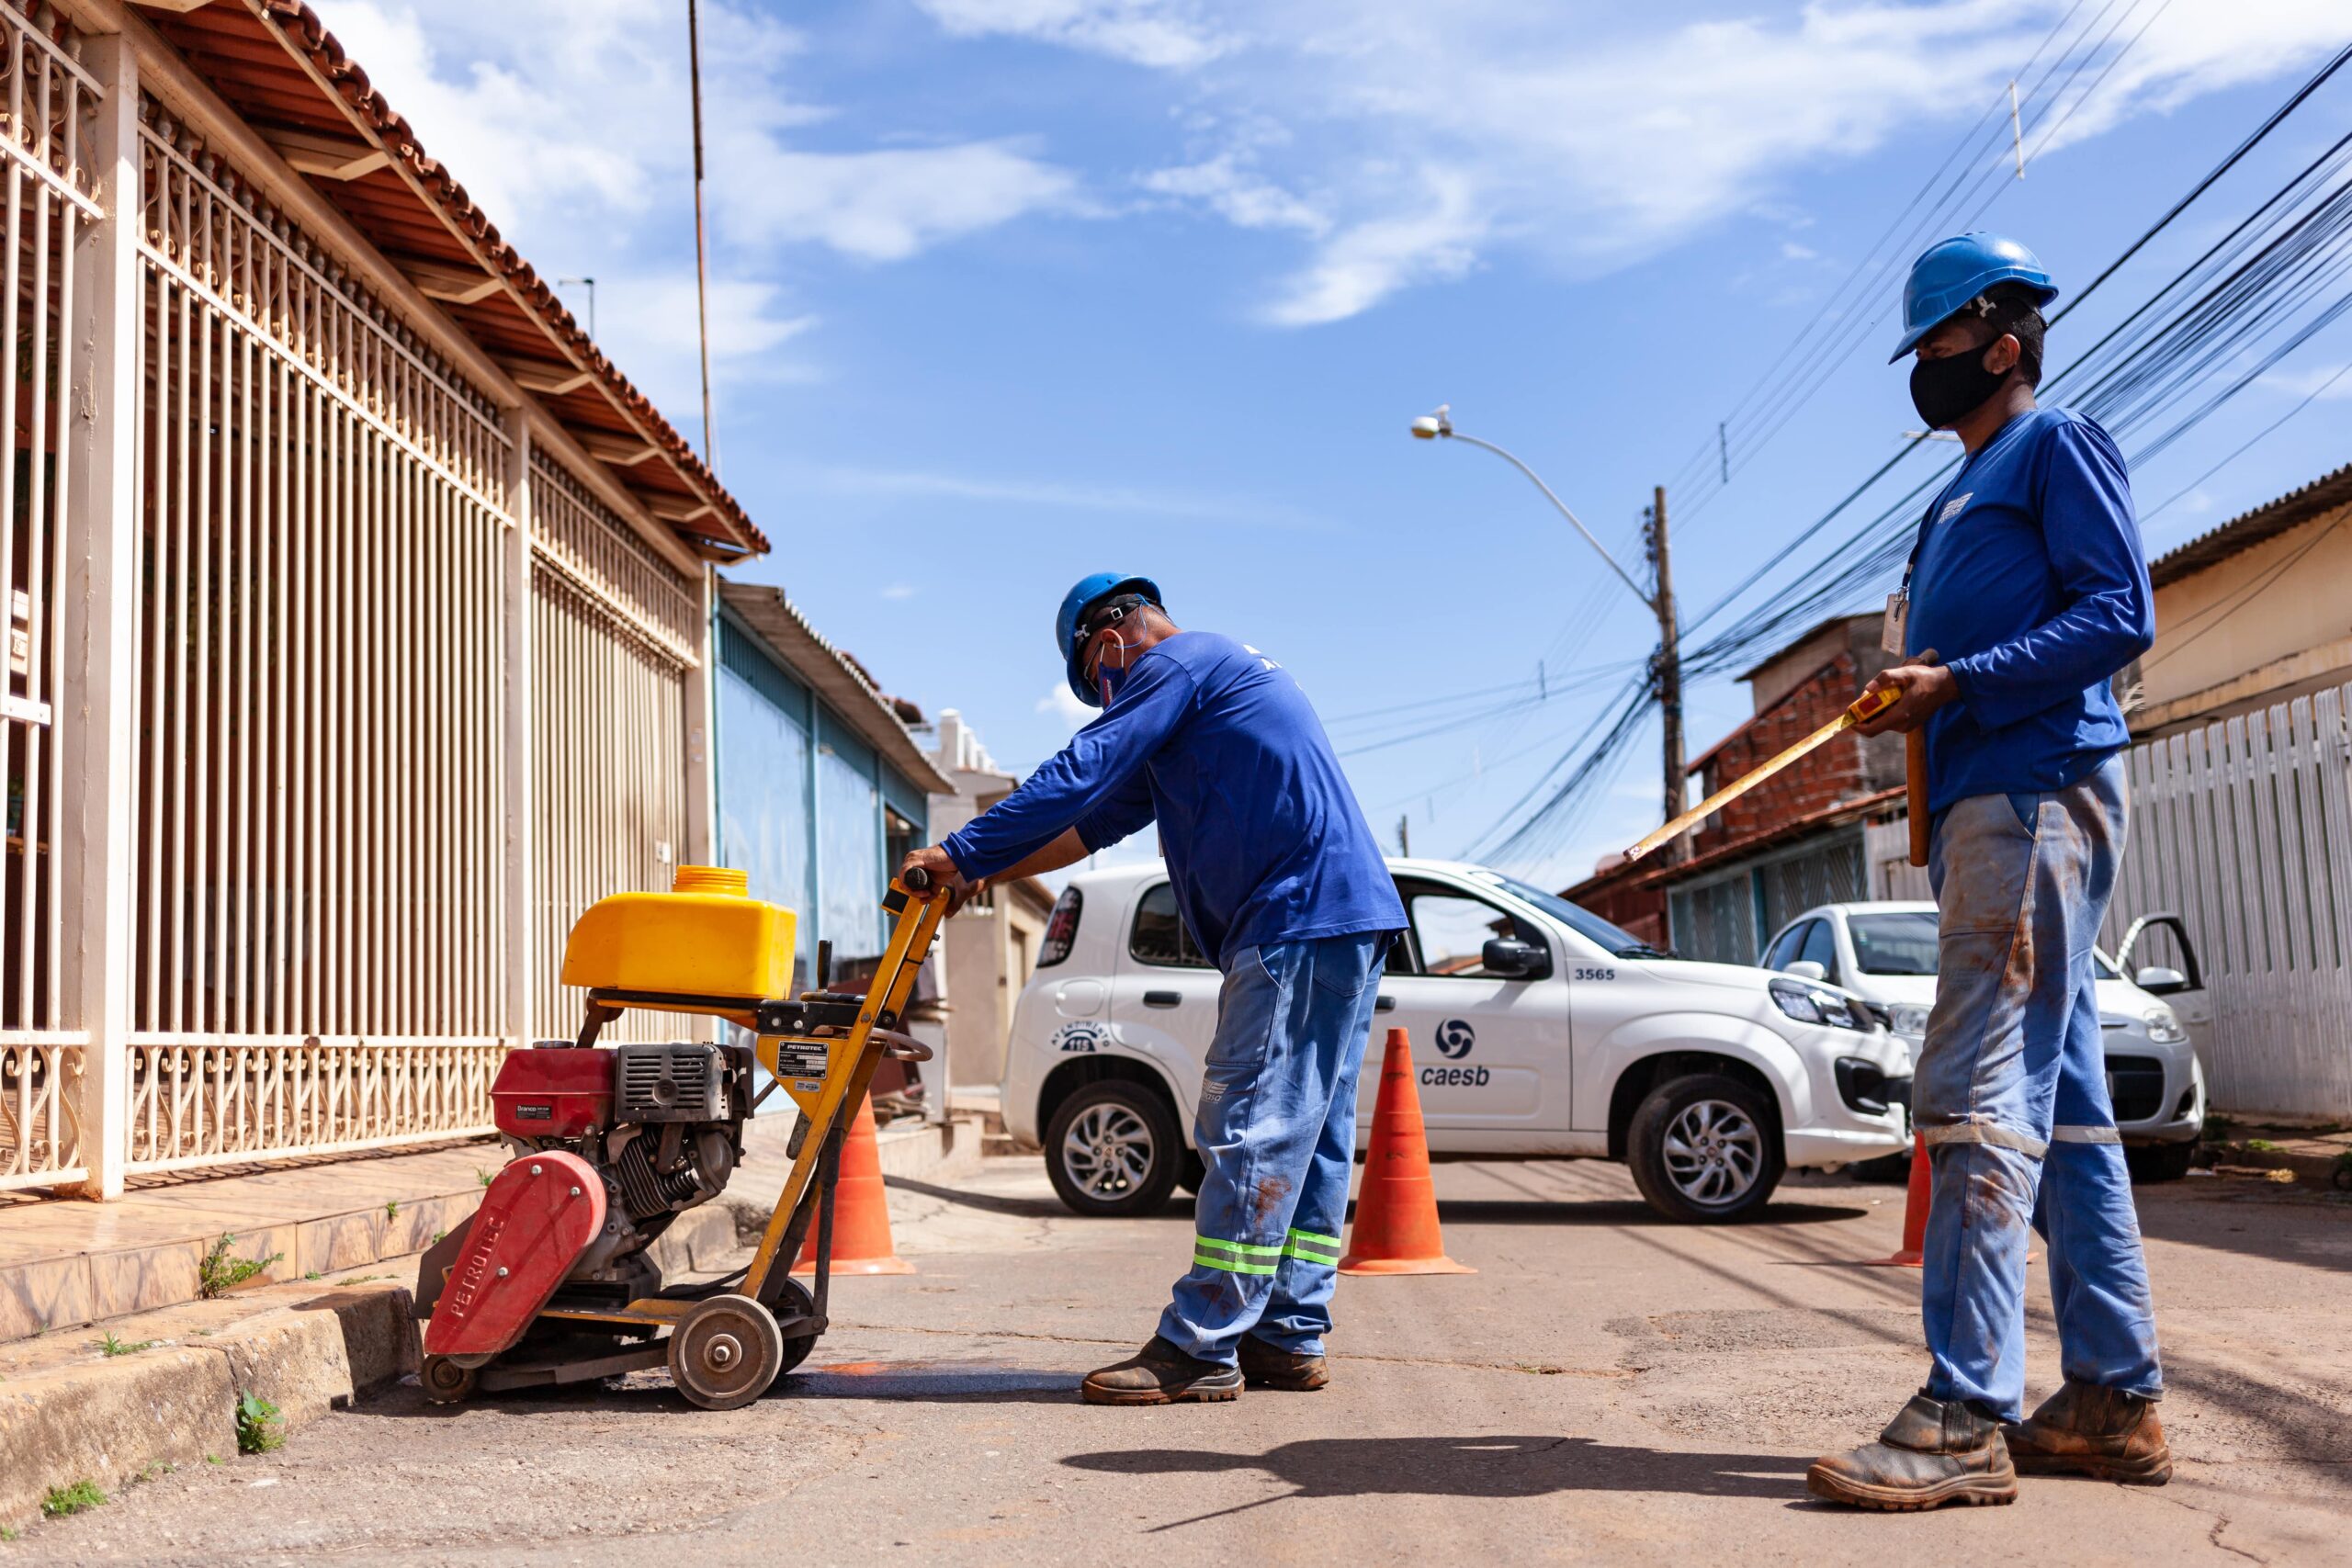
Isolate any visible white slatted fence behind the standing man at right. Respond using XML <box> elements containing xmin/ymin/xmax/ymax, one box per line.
<box><xmin>1868</xmin><ymin>686</ymin><xmax>2352</xmax><ymax>1119</ymax></box>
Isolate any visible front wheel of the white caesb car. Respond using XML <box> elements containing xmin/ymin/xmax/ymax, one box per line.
<box><xmin>1625</xmin><ymin>1072</ymin><xmax>1788</xmax><ymax>1224</ymax></box>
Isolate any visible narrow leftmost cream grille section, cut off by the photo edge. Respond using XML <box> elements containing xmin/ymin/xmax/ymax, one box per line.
<box><xmin>0</xmin><ymin>7</ymin><xmax>104</xmax><ymax>1190</ymax></box>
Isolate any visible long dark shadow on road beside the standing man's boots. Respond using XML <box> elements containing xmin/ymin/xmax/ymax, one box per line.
<box><xmin>1063</xmin><ymin>1437</ymin><xmax>1811</xmax><ymax>1530</ymax></box>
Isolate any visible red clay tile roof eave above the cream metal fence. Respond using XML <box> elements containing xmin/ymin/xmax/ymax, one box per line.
<box><xmin>131</xmin><ymin>0</ymin><xmax>769</xmax><ymax>559</ymax></box>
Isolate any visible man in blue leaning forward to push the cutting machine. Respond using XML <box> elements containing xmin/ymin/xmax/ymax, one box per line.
<box><xmin>908</xmin><ymin>571</ymin><xmax>1404</xmax><ymax>1404</ymax></box>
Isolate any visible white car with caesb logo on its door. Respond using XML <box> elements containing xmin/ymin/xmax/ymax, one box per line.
<box><xmin>1004</xmin><ymin>861</ymin><xmax>1910</xmax><ymax>1220</ymax></box>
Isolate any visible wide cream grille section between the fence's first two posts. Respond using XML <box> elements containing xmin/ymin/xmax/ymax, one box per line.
<box><xmin>130</xmin><ymin>101</ymin><xmax>508</xmax><ymax>1168</ymax></box>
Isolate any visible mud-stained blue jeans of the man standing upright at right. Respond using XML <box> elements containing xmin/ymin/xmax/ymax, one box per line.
<box><xmin>1912</xmin><ymin>757</ymin><xmax>2164</xmax><ymax>1420</ymax></box>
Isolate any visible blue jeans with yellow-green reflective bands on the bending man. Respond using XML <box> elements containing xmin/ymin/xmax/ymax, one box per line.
<box><xmin>1159</xmin><ymin>931</ymin><xmax>1387</xmax><ymax>1366</ymax></box>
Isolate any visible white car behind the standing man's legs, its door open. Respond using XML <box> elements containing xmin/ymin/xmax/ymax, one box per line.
<box><xmin>1761</xmin><ymin>900</ymin><xmax>2206</xmax><ymax>1180</ymax></box>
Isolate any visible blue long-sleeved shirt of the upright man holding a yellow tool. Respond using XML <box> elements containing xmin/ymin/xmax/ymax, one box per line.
<box><xmin>1905</xmin><ymin>409</ymin><xmax>2157</xmax><ymax>811</ymax></box>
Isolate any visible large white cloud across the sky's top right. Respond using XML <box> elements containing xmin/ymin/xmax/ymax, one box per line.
<box><xmin>922</xmin><ymin>0</ymin><xmax>2343</xmax><ymax>327</ymax></box>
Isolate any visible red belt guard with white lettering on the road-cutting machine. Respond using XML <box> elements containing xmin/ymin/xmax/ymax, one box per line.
<box><xmin>425</xmin><ymin>1152</ymin><xmax>612</xmax><ymax>1357</ymax></box>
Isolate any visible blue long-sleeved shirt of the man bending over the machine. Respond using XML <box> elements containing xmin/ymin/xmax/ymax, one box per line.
<box><xmin>944</xmin><ymin>632</ymin><xmax>1404</xmax><ymax>968</ymax></box>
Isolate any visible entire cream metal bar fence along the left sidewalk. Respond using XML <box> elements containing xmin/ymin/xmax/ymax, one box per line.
<box><xmin>0</xmin><ymin>24</ymin><xmax>708</xmax><ymax>1192</ymax></box>
